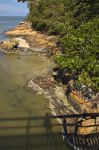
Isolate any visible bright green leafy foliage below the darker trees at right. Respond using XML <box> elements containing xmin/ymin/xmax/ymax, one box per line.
<box><xmin>55</xmin><ymin>18</ymin><xmax>99</xmax><ymax>90</ymax></box>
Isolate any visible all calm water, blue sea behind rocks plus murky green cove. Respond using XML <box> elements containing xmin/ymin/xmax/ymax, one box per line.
<box><xmin>0</xmin><ymin>17</ymin><xmax>71</xmax><ymax>149</ymax></box>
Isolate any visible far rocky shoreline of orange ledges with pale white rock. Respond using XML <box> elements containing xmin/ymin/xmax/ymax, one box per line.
<box><xmin>0</xmin><ymin>22</ymin><xmax>60</xmax><ymax>57</ymax></box>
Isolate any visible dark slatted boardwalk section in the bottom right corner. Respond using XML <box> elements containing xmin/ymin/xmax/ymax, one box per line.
<box><xmin>66</xmin><ymin>134</ymin><xmax>99</xmax><ymax>150</ymax></box>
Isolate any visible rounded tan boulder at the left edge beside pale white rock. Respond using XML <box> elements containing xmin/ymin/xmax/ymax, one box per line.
<box><xmin>1</xmin><ymin>39</ymin><xmax>19</xmax><ymax>50</ymax></box>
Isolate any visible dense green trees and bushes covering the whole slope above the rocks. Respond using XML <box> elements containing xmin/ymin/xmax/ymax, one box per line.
<box><xmin>18</xmin><ymin>0</ymin><xmax>99</xmax><ymax>91</ymax></box>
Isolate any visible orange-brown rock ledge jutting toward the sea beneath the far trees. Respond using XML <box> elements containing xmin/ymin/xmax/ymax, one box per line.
<box><xmin>4</xmin><ymin>22</ymin><xmax>60</xmax><ymax>56</ymax></box>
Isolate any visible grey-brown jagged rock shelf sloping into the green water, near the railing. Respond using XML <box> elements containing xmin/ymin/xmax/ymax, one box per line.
<box><xmin>28</xmin><ymin>73</ymin><xmax>77</xmax><ymax>128</ymax></box>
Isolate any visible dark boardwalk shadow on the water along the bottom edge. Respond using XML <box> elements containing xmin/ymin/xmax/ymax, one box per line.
<box><xmin>0</xmin><ymin>133</ymin><xmax>69</xmax><ymax>150</ymax></box>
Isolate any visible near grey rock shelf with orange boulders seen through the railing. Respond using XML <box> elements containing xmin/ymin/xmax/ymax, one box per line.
<box><xmin>28</xmin><ymin>73</ymin><xmax>99</xmax><ymax>135</ymax></box>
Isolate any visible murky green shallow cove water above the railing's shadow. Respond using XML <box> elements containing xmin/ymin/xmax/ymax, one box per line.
<box><xmin>0</xmin><ymin>54</ymin><xmax>48</xmax><ymax>112</ymax></box>
